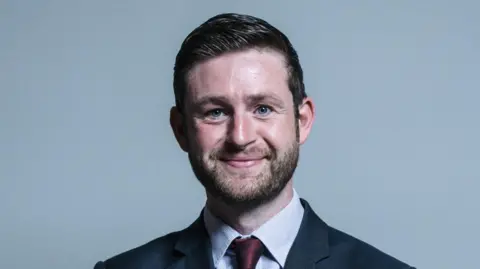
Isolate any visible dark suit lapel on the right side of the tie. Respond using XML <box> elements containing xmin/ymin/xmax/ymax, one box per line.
<box><xmin>285</xmin><ymin>199</ymin><xmax>329</xmax><ymax>269</ymax></box>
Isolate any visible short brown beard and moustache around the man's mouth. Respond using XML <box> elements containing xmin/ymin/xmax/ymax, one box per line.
<box><xmin>188</xmin><ymin>135</ymin><xmax>299</xmax><ymax>208</ymax></box>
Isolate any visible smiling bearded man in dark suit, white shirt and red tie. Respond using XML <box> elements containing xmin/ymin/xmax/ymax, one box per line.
<box><xmin>95</xmin><ymin>14</ymin><xmax>411</xmax><ymax>269</ymax></box>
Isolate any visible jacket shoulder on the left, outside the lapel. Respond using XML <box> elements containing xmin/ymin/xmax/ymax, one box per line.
<box><xmin>94</xmin><ymin>231</ymin><xmax>181</xmax><ymax>269</ymax></box>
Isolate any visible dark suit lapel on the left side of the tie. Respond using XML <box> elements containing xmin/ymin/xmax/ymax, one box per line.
<box><xmin>168</xmin><ymin>211</ymin><xmax>213</xmax><ymax>269</ymax></box>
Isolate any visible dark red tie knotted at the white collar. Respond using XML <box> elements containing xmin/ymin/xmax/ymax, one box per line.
<box><xmin>230</xmin><ymin>237</ymin><xmax>264</xmax><ymax>269</ymax></box>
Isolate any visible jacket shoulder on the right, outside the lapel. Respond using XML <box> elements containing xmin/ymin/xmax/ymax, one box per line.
<box><xmin>328</xmin><ymin>227</ymin><xmax>413</xmax><ymax>269</ymax></box>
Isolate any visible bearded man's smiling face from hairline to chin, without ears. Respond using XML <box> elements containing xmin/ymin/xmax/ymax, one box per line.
<box><xmin>171</xmin><ymin>49</ymin><xmax>314</xmax><ymax>204</ymax></box>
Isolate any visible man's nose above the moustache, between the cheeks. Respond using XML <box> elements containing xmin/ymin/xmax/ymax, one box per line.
<box><xmin>228</xmin><ymin>114</ymin><xmax>256</xmax><ymax>148</ymax></box>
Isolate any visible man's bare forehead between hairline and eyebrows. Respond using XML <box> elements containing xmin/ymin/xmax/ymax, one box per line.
<box><xmin>186</xmin><ymin>49</ymin><xmax>291</xmax><ymax>100</ymax></box>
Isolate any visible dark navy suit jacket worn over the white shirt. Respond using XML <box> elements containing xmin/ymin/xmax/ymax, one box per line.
<box><xmin>94</xmin><ymin>199</ymin><xmax>414</xmax><ymax>269</ymax></box>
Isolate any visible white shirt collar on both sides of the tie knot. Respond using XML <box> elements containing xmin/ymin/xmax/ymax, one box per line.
<box><xmin>204</xmin><ymin>190</ymin><xmax>304</xmax><ymax>267</ymax></box>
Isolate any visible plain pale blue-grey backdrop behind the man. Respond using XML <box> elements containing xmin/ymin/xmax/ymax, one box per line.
<box><xmin>0</xmin><ymin>0</ymin><xmax>480</xmax><ymax>269</ymax></box>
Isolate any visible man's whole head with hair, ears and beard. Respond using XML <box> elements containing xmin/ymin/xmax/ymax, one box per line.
<box><xmin>170</xmin><ymin>14</ymin><xmax>314</xmax><ymax>206</ymax></box>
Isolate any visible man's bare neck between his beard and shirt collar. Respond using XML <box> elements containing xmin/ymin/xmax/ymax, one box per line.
<box><xmin>207</xmin><ymin>180</ymin><xmax>293</xmax><ymax>235</ymax></box>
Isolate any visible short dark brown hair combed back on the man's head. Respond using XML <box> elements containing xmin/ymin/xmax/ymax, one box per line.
<box><xmin>173</xmin><ymin>13</ymin><xmax>307</xmax><ymax>114</ymax></box>
